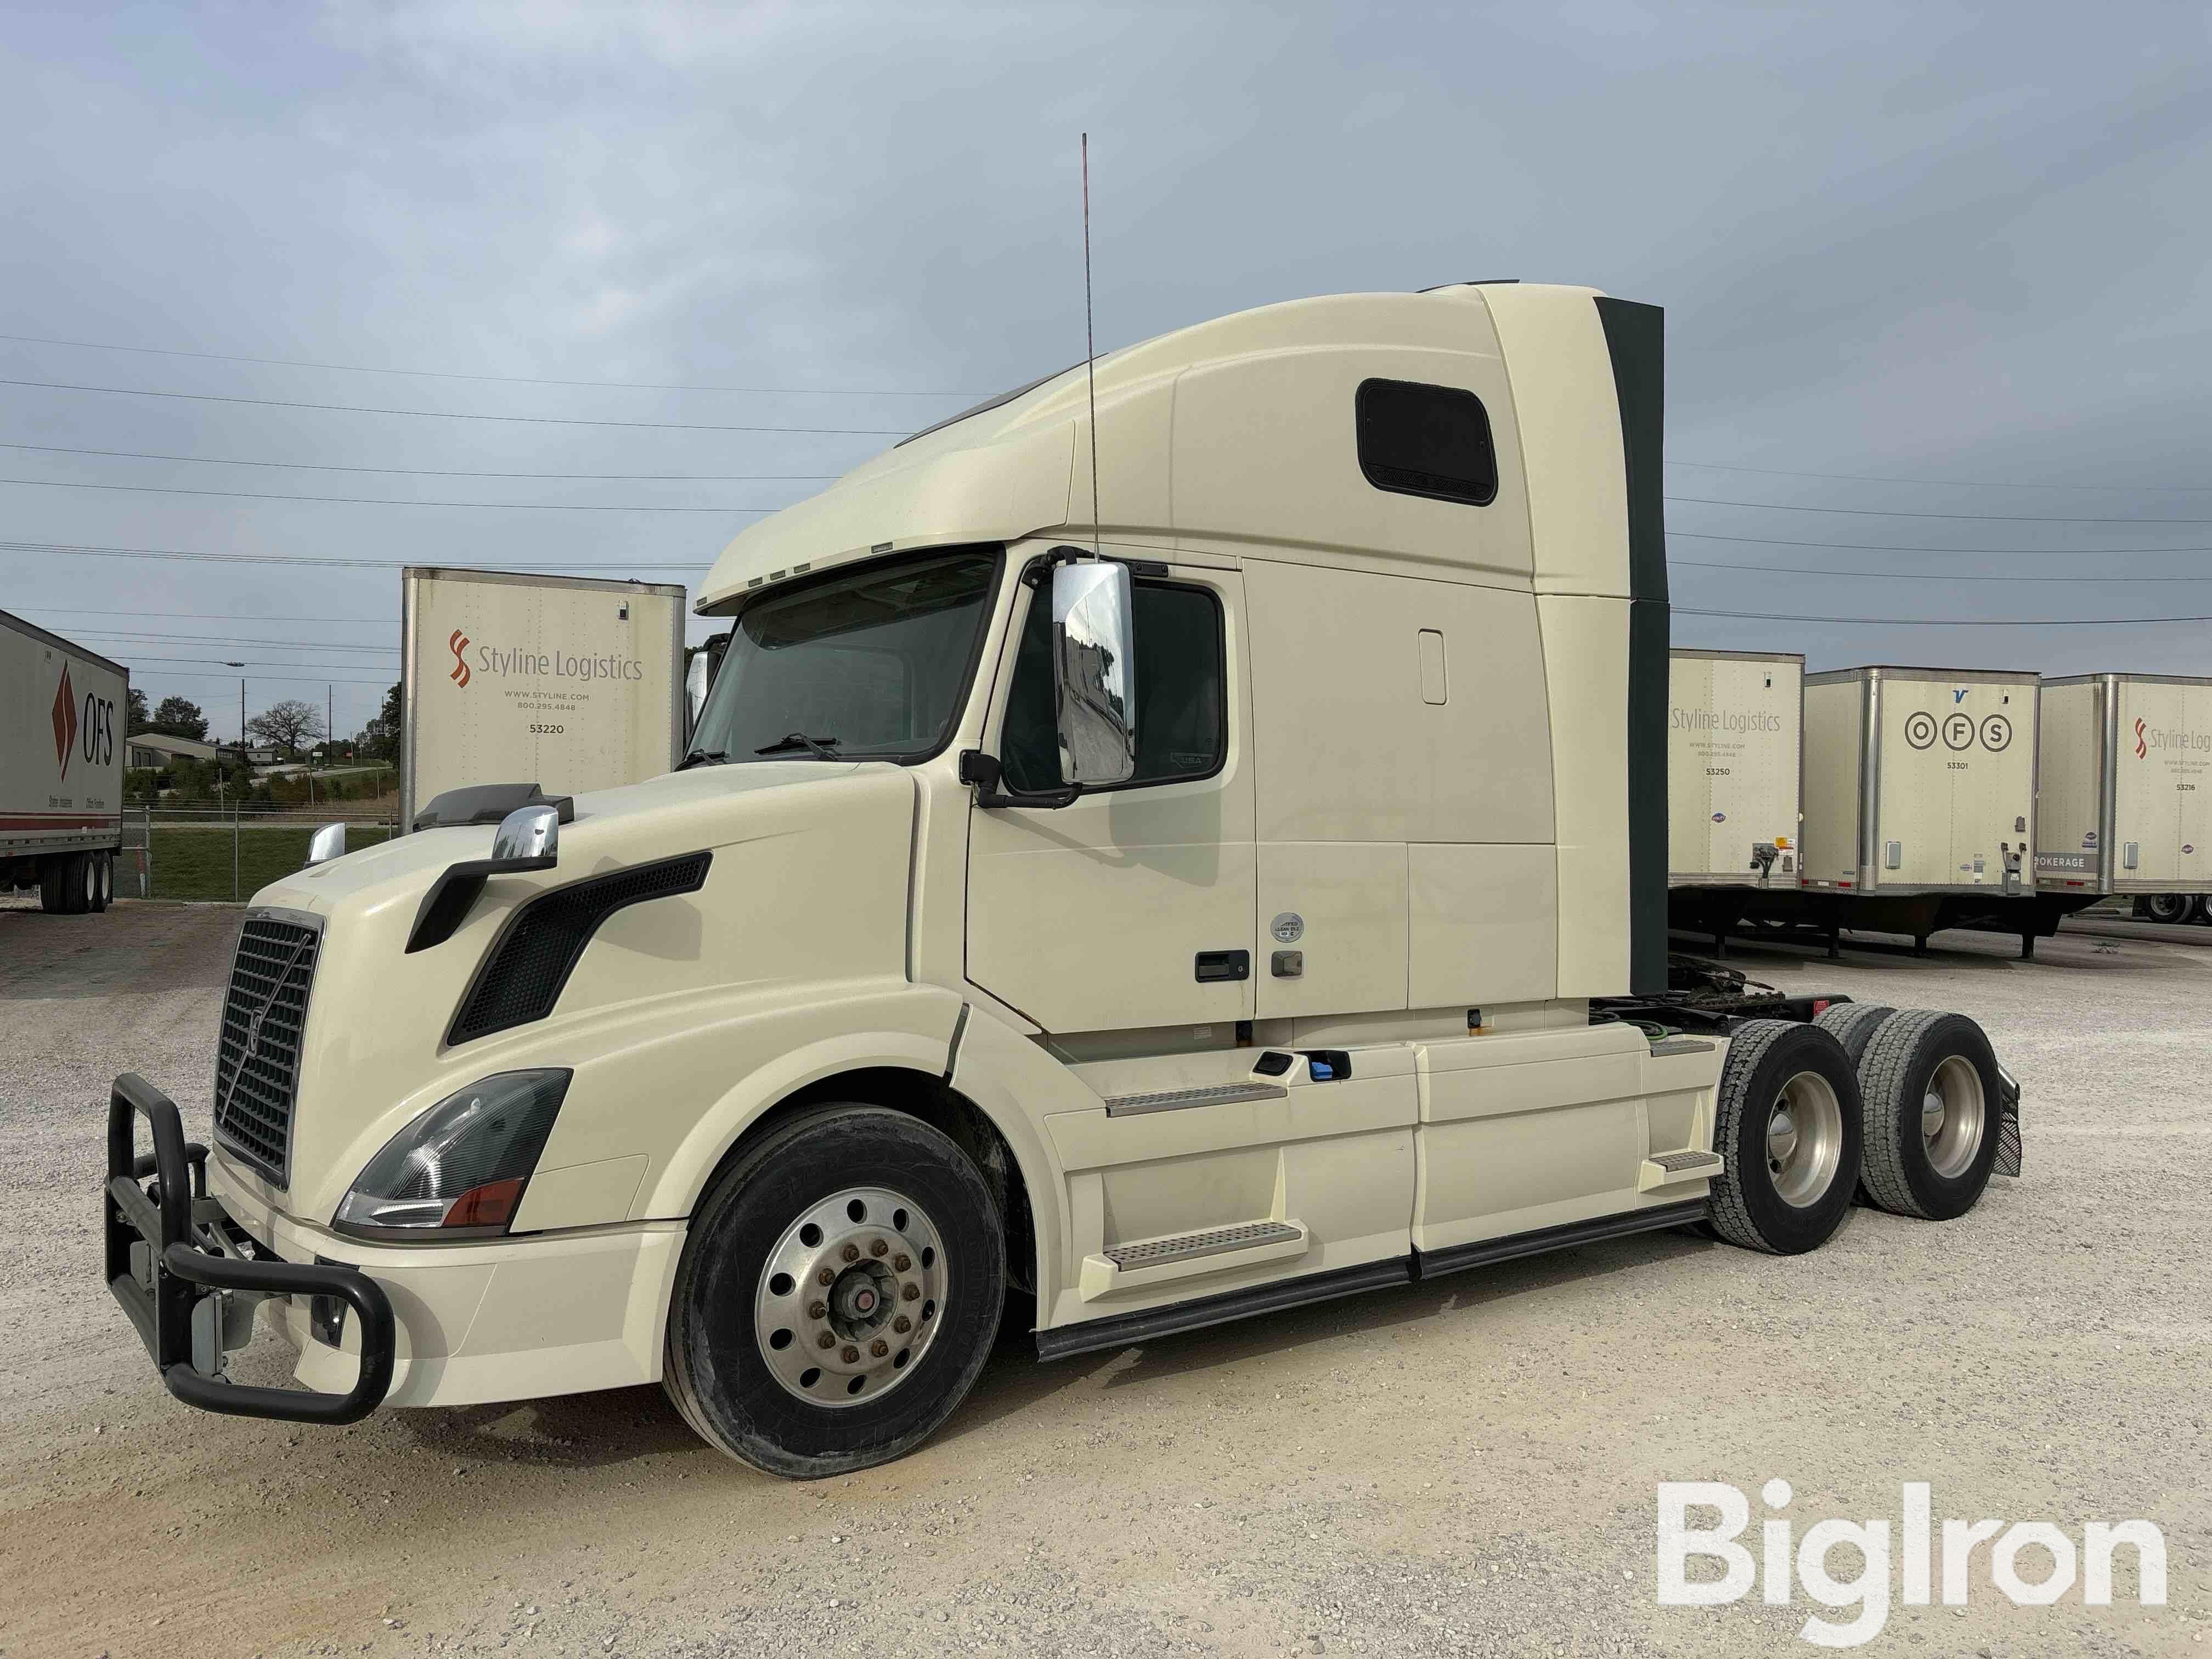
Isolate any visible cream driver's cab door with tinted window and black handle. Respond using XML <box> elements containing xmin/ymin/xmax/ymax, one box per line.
<box><xmin>967</xmin><ymin>566</ymin><xmax>1254</xmax><ymax>1037</ymax></box>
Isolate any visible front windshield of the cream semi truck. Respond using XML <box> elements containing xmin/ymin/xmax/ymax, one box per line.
<box><xmin>692</xmin><ymin>549</ymin><xmax>997</xmax><ymax>761</ymax></box>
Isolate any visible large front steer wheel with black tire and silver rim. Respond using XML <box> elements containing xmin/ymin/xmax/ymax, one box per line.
<box><xmin>666</xmin><ymin>1104</ymin><xmax>1007</xmax><ymax>1480</ymax></box>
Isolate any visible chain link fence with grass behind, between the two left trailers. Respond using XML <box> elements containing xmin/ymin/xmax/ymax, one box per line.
<box><xmin>115</xmin><ymin>799</ymin><xmax>398</xmax><ymax>900</ymax></box>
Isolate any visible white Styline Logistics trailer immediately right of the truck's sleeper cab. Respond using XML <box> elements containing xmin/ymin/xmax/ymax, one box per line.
<box><xmin>1666</xmin><ymin>650</ymin><xmax>1805</xmax><ymax>887</ymax></box>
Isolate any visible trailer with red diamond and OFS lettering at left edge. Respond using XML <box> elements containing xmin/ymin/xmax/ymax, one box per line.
<box><xmin>0</xmin><ymin>611</ymin><xmax>131</xmax><ymax>913</ymax></box>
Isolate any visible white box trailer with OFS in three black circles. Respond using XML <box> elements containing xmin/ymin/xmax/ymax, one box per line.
<box><xmin>1801</xmin><ymin>666</ymin><xmax>2037</xmax><ymax>898</ymax></box>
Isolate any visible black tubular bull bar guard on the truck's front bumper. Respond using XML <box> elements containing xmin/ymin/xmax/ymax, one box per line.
<box><xmin>101</xmin><ymin>1070</ymin><xmax>396</xmax><ymax>1423</ymax></box>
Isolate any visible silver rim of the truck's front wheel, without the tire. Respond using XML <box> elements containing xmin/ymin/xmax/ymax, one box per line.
<box><xmin>752</xmin><ymin>1186</ymin><xmax>949</xmax><ymax>1411</ymax></box>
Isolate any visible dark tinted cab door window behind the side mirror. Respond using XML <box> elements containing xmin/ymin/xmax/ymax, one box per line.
<box><xmin>1000</xmin><ymin>582</ymin><xmax>1228</xmax><ymax>792</ymax></box>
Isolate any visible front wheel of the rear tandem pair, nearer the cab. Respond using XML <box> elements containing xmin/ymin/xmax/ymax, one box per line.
<box><xmin>1712</xmin><ymin>1020</ymin><xmax>1860</xmax><ymax>1256</ymax></box>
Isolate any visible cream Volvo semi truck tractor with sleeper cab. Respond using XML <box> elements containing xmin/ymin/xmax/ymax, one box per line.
<box><xmin>106</xmin><ymin>283</ymin><xmax>2017</xmax><ymax>1475</ymax></box>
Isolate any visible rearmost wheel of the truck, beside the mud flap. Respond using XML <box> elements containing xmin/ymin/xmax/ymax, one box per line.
<box><xmin>1860</xmin><ymin>1009</ymin><xmax>2004</xmax><ymax>1221</ymax></box>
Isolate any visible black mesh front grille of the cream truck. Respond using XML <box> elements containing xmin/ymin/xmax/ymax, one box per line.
<box><xmin>215</xmin><ymin>916</ymin><xmax>323</xmax><ymax>1183</ymax></box>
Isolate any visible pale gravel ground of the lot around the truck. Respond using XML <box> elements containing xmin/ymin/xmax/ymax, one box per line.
<box><xmin>0</xmin><ymin>902</ymin><xmax>2212</xmax><ymax>1659</ymax></box>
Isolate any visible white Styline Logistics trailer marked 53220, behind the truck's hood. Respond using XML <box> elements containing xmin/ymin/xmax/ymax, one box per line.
<box><xmin>400</xmin><ymin>566</ymin><xmax>686</xmax><ymax>827</ymax></box>
